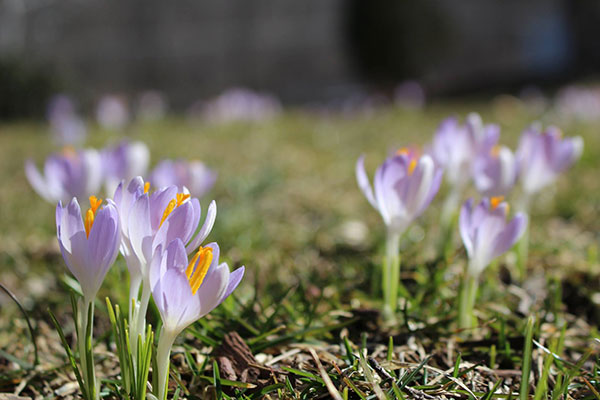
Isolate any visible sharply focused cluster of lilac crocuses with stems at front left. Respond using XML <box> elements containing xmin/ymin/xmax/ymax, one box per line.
<box><xmin>56</xmin><ymin>177</ymin><xmax>244</xmax><ymax>399</ymax></box>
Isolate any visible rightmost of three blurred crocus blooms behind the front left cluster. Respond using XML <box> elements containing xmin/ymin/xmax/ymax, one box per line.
<box><xmin>150</xmin><ymin>160</ymin><xmax>217</xmax><ymax>197</ymax></box>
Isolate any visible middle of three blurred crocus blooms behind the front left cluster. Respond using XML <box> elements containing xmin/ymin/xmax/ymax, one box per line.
<box><xmin>102</xmin><ymin>140</ymin><xmax>150</xmax><ymax>193</ymax></box>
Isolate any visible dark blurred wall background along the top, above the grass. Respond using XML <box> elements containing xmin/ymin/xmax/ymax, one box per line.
<box><xmin>0</xmin><ymin>0</ymin><xmax>600</xmax><ymax>117</ymax></box>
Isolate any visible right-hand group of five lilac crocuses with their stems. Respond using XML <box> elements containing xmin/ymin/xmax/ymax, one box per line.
<box><xmin>356</xmin><ymin>114</ymin><xmax>583</xmax><ymax>327</ymax></box>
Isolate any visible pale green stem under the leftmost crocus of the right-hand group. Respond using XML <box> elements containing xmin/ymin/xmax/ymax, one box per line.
<box><xmin>382</xmin><ymin>230</ymin><xmax>400</xmax><ymax>321</ymax></box>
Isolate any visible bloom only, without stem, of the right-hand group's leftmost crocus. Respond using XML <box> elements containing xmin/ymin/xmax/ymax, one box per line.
<box><xmin>356</xmin><ymin>149</ymin><xmax>442</xmax><ymax>234</ymax></box>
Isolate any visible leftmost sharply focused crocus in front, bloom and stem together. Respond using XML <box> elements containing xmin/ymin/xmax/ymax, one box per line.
<box><xmin>56</xmin><ymin>196</ymin><xmax>121</xmax><ymax>399</ymax></box>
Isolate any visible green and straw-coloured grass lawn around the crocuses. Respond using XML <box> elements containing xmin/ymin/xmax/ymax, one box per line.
<box><xmin>0</xmin><ymin>97</ymin><xmax>600</xmax><ymax>399</ymax></box>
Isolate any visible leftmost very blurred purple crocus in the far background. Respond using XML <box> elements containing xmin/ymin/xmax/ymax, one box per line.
<box><xmin>46</xmin><ymin>94</ymin><xmax>87</xmax><ymax>146</ymax></box>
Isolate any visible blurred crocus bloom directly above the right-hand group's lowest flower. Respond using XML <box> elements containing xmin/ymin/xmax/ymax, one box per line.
<box><xmin>473</xmin><ymin>145</ymin><xmax>518</xmax><ymax>197</ymax></box>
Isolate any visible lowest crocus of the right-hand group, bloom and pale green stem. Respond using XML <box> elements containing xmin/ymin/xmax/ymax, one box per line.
<box><xmin>459</xmin><ymin>197</ymin><xmax>527</xmax><ymax>328</ymax></box>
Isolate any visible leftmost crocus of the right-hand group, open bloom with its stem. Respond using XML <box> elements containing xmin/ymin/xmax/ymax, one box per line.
<box><xmin>356</xmin><ymin>149</ymin><xmax>442</xmax><ymax>319</ymax></box>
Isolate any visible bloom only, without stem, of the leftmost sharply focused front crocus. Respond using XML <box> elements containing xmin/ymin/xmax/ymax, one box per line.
<box><xmin>56</xmin><ymin>196</ymin><xmax>121</xmax><ymax>300</ymax></box>
